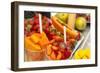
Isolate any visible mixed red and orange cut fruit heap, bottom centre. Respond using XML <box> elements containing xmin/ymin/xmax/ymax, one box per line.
<box><xmin>46</xmin><ymin>40</ymin><xmax>72</xmax><ymax>60</ymax></box>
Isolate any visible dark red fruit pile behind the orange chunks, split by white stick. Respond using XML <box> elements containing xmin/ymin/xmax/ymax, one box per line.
<box><xmin>24</xmin><ymin>13</ymin><xmax>51</xmax><ymax>36</ymax></box>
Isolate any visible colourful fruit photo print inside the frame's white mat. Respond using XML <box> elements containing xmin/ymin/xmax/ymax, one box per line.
<box><xmin>24</xmin><ymin>12</ymin><xmax>90</xmax><ymax>61</ymax></box>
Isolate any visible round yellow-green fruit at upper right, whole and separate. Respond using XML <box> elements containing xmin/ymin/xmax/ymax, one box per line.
<box><xmin>75</xmin><ymin>17</ymin><xmax>87</xmax><ymax>30</ymax></box>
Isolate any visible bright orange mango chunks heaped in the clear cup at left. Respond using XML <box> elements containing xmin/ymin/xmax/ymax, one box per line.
<box><xmin>25</xmin><ymin>32</ymin><xmax>49</xmax><ymax>51</ymax></box>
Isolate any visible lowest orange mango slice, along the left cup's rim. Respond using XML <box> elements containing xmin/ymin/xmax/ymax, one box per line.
<box><xmin>25</xmin><ymin>37</ymin><xmax>41</xmax><ymax>51</ymax></box>
